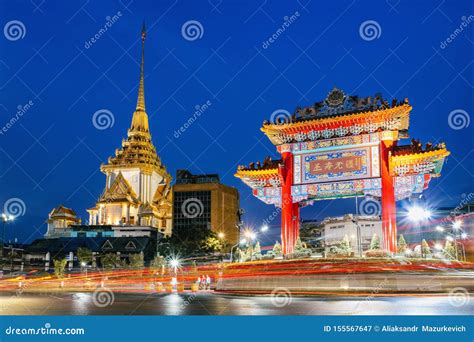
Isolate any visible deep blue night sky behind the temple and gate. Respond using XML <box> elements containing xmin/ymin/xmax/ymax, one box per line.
<box><xmin>0</xmin><ymin>0</ymin><xmax>474</xmax><ymax>246</ymax></box>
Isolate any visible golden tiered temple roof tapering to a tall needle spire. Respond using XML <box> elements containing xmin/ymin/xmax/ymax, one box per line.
<box><xmin>101</xmin><ymin>25</ymin><xmax>169</xmax><ymax>177</ymax></box>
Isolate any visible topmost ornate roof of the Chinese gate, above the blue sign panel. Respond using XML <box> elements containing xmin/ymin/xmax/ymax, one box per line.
<box><xmin>261</xmin><ymin>88</ymin><xmax>412</xmax><ymax>145</ymax></box>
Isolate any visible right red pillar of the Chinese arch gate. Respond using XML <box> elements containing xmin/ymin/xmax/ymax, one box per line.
<box><xmin>380</xmin><ymin>141</ymin><xmax>397</xmax><ymax>253</ymax></box>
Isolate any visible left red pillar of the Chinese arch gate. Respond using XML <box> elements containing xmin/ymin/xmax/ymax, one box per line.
<box><xmin>279</xmin><ymin>152</ymin><xmax>299</xmax><ymax>255</ymax></box>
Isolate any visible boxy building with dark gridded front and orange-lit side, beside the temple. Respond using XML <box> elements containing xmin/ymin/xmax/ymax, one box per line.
<box><xmin>173</xmin><ymin>170</ymin><xmax>240</xmax><ymax>248</ymax></box>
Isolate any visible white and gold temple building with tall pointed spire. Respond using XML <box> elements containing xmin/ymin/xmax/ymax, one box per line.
<box><xmin>87</xmin><ymin>26</ymin><xmax>172</xmax><ymax>235</ymax></box>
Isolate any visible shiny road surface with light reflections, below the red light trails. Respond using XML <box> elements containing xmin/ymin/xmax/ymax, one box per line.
<box><xmin>0</xmin><ymin>292</ymin><xmax>474</xmax><ymax>315</ymax></box>
